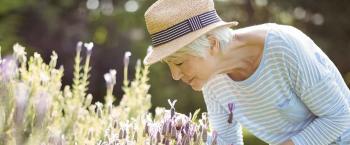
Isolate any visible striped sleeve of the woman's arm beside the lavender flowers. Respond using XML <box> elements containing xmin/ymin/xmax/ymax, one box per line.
<box><xmin>203</xmin><ymin>90</ymin><xmax>243</xmax><ymax>145</ymax></box>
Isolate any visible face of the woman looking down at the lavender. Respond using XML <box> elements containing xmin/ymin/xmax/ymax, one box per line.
<box><xmin>166</xmin><ymin>54</ymin><xmax>215</xmax><ymax>91</ymax></box>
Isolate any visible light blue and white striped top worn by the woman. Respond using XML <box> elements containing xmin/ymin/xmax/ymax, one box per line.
<box><xmin>202</xmin><ymin>24</ymin><xmax>350</xmax><ymax>145</ymax></box>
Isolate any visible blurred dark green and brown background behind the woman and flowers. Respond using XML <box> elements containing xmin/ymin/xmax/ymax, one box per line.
<box><xmin>0</xmin><ymin>0</ymin><xmax>350</xmax><ymax>145</ymax></box>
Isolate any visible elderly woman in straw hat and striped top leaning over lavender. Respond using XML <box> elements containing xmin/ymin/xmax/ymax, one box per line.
<box><xmin>144</xmin><ymin>0</ymin><xmax>350</xmax><ymax>145</ymax></box>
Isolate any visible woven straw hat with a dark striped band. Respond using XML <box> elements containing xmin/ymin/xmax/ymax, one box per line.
<box><xmin>144</xmin><ymin>0</ymin><xmax>238</xmax><ymax>65</ymax></box>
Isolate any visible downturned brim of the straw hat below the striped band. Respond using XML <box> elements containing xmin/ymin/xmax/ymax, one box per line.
<box><xmin>143</xmin><ymin>21</ymin><xmax>238</xmax><ymax>65</ymax></box>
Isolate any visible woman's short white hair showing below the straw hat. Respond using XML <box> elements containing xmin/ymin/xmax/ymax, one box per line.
<box><xmin>164</xmin><ymin>27</ymin><xmax>234</xmax><ymax>62</ymax></box>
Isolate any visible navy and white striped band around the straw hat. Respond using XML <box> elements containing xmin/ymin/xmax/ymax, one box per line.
<box><xmin>151</xmin><ymin>10</ymin><xmax>221</xmax><ymax>47</ymax></box>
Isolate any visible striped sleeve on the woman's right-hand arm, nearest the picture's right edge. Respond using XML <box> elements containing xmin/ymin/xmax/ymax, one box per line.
<box><xmin>281</xmin><ymin>24</ymin><xmax>350</xmax><ymax>145</ymax></box>
